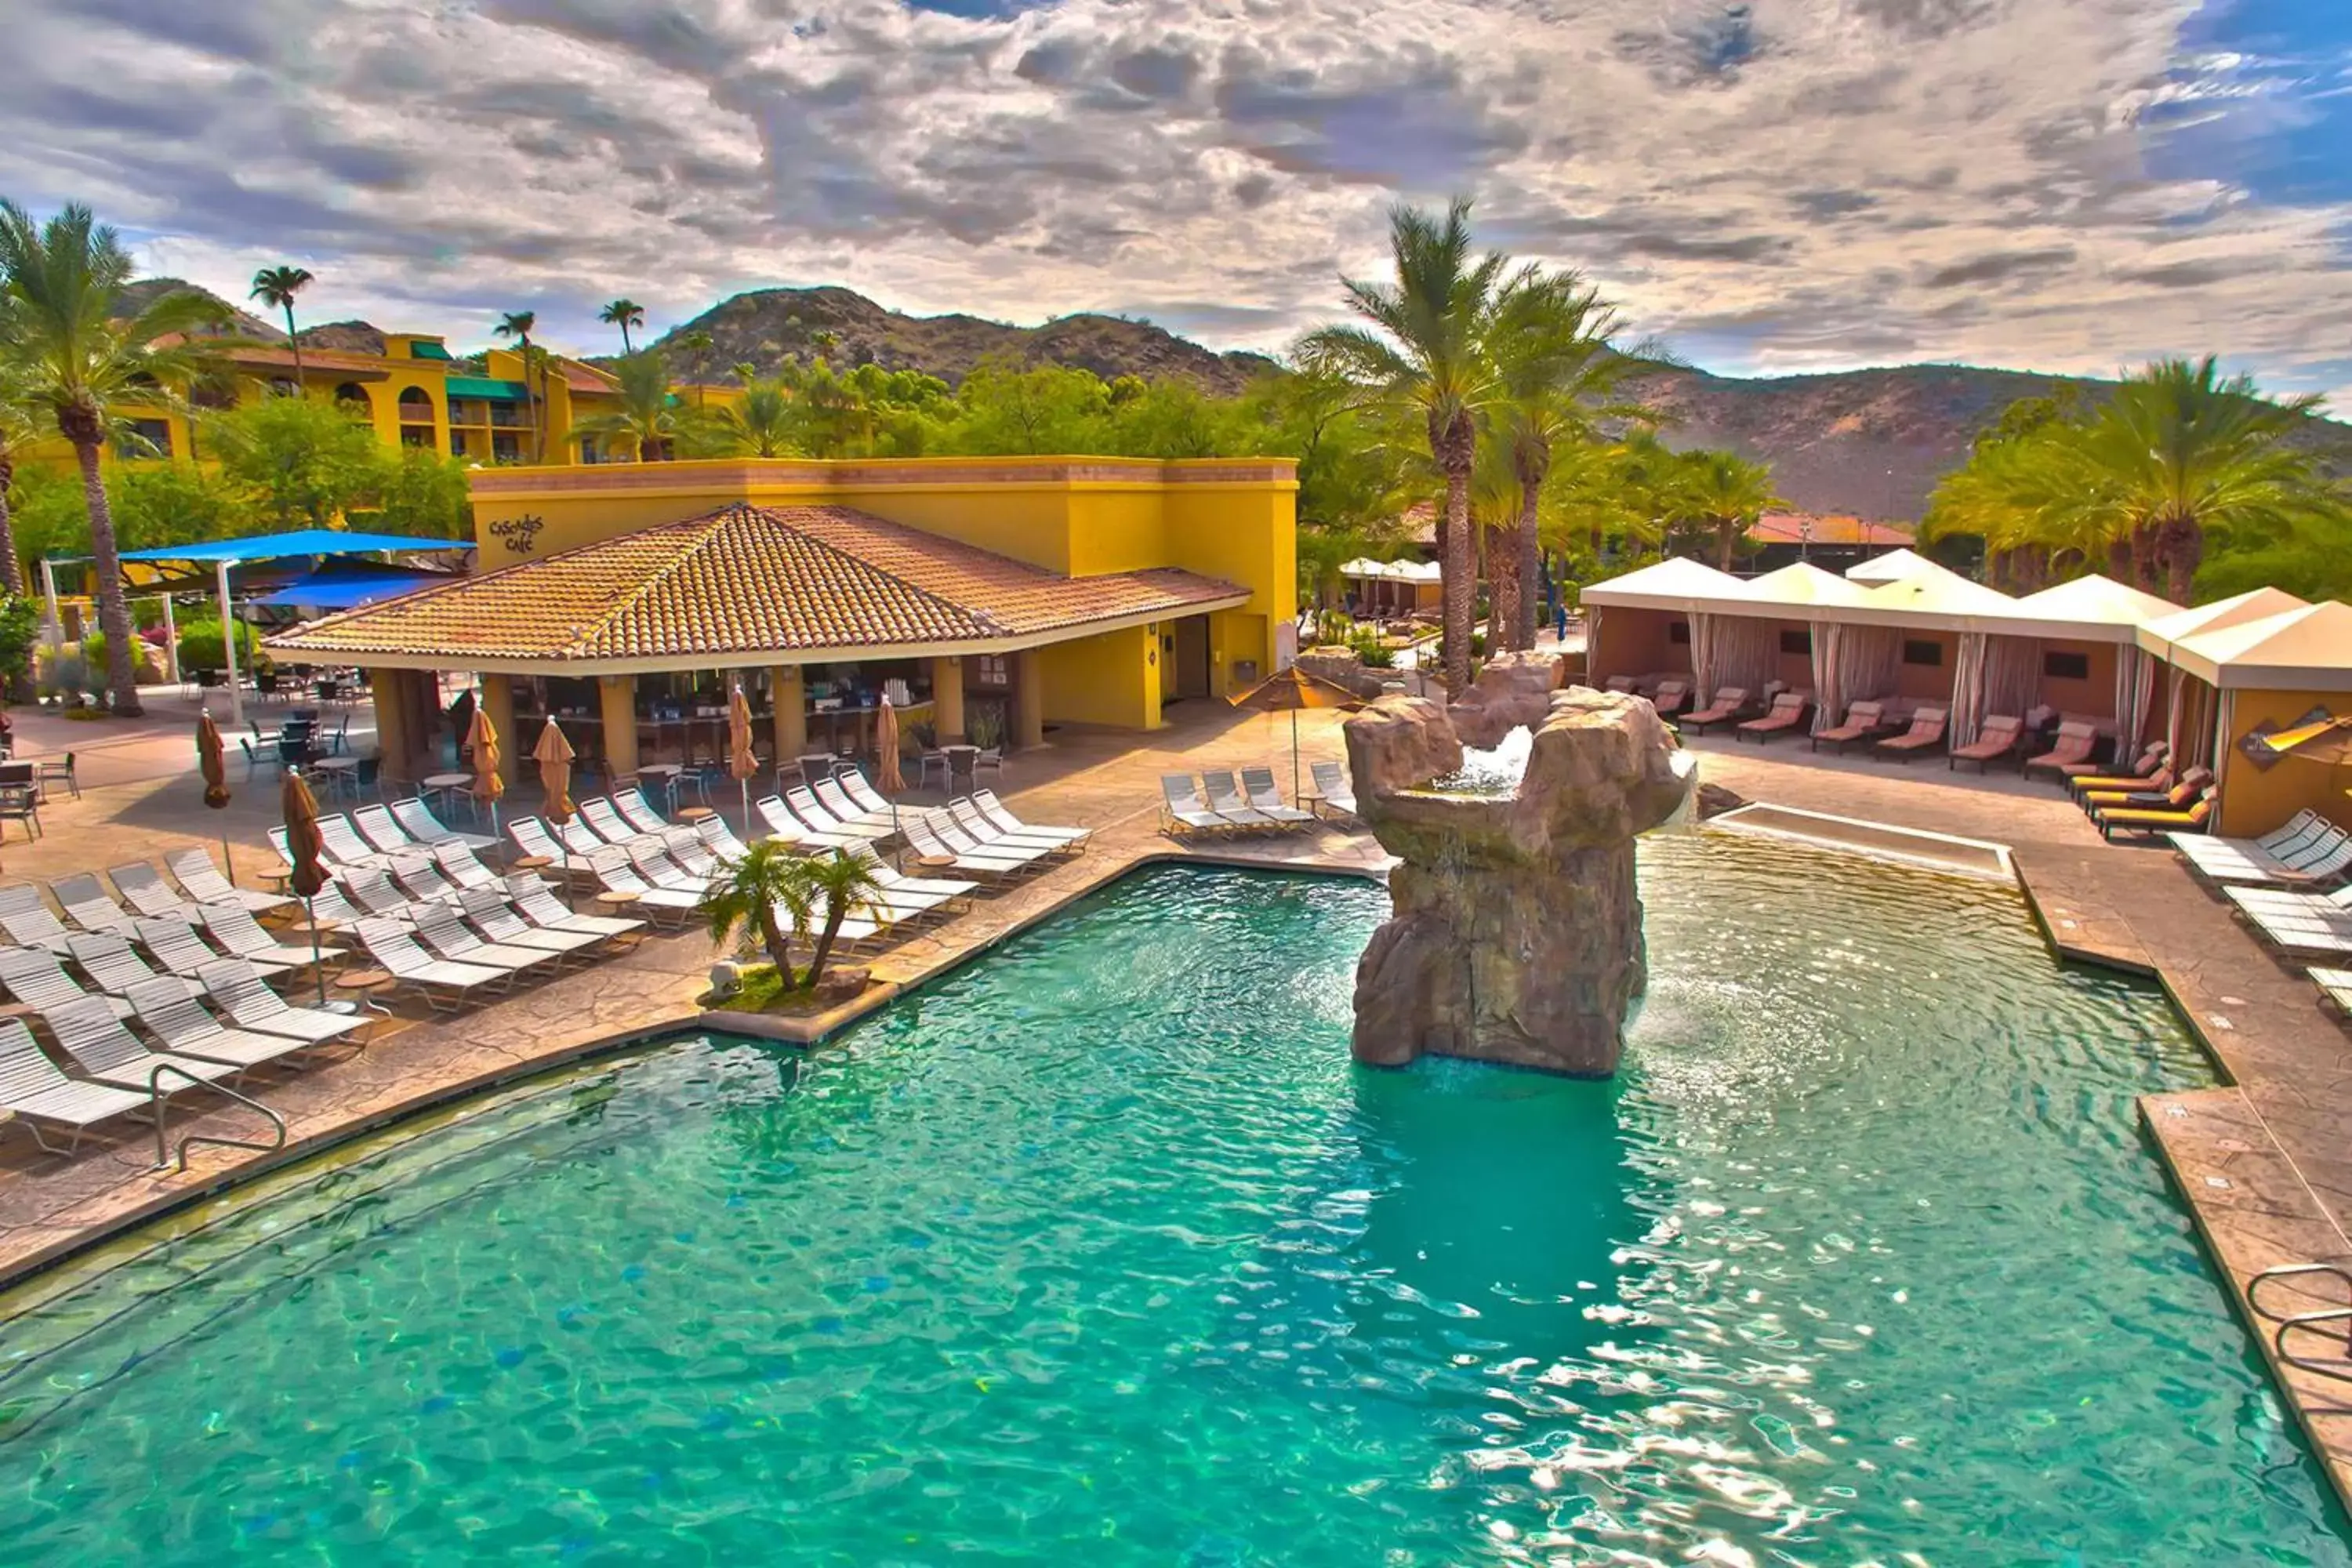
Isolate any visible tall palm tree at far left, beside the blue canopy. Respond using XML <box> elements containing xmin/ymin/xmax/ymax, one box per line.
<box><xmin>0</xmin><ymin>198</ymin><xmax>226</xmax><ymax>715</ymax></box>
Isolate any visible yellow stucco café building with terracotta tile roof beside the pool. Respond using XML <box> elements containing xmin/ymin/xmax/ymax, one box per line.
<box><xmin>270</xmin><ymin>456</ymin><xmax>1298</xmax><ymax>776</ymax></box>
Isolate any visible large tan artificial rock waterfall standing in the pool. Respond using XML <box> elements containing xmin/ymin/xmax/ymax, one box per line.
<box><xmin>1345</xmin><ymin>687</ymin><xmax>1691</xmax><ymax>1076</ymax></box>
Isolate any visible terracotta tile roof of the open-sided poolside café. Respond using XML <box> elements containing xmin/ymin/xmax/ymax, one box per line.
<box><xmin>268</xmin><ymin>506</ymin><xmax>1247</xmax><ymax>663</ymax></box>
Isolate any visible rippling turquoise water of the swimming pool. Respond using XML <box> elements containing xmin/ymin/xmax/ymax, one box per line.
<box><xmin>0</xmin><ymin>834</ymin><xmax>2352</xmax><ymax>1568</ymax></box>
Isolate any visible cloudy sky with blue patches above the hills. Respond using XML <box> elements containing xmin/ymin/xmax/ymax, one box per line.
<box><xmin>0</xmin><ymin>0</ymin><xmax>2352</xmax><ymax>402</ymax></box>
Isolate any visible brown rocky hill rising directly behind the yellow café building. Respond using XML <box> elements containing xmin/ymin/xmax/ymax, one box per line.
<box><xmin>656</xmin><ymin>289</ymin><xmax>1270</xmax><ymax>395</ymax></box>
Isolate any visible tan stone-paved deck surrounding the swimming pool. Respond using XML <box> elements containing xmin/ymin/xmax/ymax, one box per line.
<box><xmin>0</xmin><ymin>719</ymin><xmax>2352</xmax><ymax>1504</ymax></box>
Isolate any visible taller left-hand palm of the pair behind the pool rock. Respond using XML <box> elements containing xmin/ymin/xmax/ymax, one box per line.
<box><xmin>1301</xmin><ymin>200</ymin><xmax>1505</xmax><ymax>694</ymax></box>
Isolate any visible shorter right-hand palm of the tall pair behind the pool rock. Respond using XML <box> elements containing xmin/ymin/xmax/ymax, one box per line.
<box><xmin>1489</xmin><ymin>268</ymin><xmax>1637</xmax><ymax>649</ymax></box>
